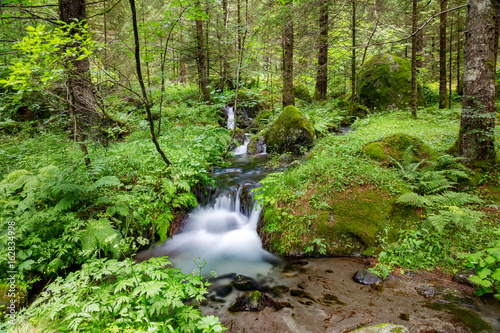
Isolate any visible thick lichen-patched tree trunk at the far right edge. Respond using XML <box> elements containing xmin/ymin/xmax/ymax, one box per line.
<box><xmin>458</xmin><ymin>0</ymin><xmax>497</xmax><ymax>162</ymax></box>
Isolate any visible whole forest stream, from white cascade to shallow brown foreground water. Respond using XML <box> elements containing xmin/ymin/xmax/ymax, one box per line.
<box><xmin>136</xmin><ymin>119</ymin><xmax>500</xmax><ymax>333</ymax></box>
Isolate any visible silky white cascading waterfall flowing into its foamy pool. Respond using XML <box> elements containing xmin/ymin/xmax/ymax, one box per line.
<box><xmin>137</xmin><ymin>111</ymin><xmax>279</xmax><ymax>276</ymax></box>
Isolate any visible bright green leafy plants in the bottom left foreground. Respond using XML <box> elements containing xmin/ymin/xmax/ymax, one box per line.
<box><xmin>10</xmin><ymin>257</ymin><xmax>225</xmax><ymax>332</ymax></box>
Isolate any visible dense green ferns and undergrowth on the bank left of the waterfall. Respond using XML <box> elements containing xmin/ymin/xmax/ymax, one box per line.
<box><xmin>0</xmin><ymin>88</ymin><xmax>230</xmax><ymax>290</ymax></box>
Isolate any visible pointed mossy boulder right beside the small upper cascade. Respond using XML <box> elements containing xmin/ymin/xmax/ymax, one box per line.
<box><xmin>266</xmin><ymin>105</ymin><xmax>316</xmax><ymax>155</ymax></box>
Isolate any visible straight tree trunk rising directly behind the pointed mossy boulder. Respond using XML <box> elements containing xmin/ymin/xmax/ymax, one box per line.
<box><xmin>283</xmin><ymin>0</ymin><xmax>295</xmax><ymax>107</ymax></box>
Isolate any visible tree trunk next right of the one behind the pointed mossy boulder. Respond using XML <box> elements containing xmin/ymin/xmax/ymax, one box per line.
<box><xmin>314</xmin><ymin>1</ymin><xmax>328</xmax><ymax>100</ymax></box>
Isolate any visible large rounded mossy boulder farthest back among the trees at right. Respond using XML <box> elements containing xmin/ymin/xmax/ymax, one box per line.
<box><xmin>357</xmin><ymin>54</ymin><xmax>425</xmax><ymax>111</ymax></box>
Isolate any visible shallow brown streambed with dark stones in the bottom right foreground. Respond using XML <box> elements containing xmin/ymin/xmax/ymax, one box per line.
<box><xmin>201</xmin><ymin>258</ymin><xmax>500</xmax><ymax>333</ymax></box>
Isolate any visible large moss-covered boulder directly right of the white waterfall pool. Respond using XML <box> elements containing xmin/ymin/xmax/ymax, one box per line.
<box><xmin>258</xmin><ymin>185</ymin><xmax>397</xmax><ymax>256</ymax></box>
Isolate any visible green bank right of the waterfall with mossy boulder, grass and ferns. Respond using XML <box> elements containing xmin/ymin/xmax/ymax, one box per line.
<box><xmin>260</xmin><ymin>108</ymin><xmax>499</xmax><ymax>290</ymax></box>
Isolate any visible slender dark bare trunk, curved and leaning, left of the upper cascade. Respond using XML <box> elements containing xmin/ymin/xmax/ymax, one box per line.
<box><xmin>129</xmin><ymin>0</ymin><xmax>171</xmax><ymax>165</ymax></box>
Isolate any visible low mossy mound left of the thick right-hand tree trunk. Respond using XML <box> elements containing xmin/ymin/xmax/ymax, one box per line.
<box><xmin>363</xmin><ymin>133</ymin><xmax>437</xmax><ymax>164</ymax></box>
